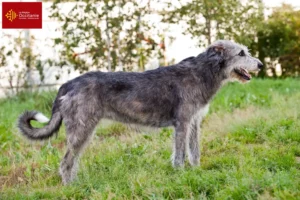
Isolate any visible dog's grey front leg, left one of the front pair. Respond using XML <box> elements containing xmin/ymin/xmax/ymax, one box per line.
<box><xmin>172</xmin><ymin>122</ymin><xmax>189</xmax><ymax>167</ymax></box>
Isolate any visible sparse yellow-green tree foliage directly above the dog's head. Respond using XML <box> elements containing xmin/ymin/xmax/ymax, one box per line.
<box><xmin>165</xmin><ymin>0</ymin><xmax>263</xmax><ymax>46</ymax></box>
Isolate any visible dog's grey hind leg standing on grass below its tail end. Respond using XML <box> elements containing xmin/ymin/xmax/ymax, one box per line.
<box><xmin>60</xmin><ymin>117</ymin><xmax>97</xmax><ymax>184</ymax></box>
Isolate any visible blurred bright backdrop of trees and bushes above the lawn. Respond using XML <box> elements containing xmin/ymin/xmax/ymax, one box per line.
<box><xmin>0</xmin><ymin>0</ymin><xmax>300</xmax><ymax>97</ymax></box>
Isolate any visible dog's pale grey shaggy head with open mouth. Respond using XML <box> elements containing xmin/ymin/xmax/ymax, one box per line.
<box><xmin>207</xmin><ymin>40</ymin><xmax>263</xmax><ymax>83</ymax></box>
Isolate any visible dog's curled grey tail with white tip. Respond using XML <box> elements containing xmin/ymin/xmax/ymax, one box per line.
<box><xmin>18</xmin><ymin>99</ymin><xmax>62</xmax><ymax>140</ymax></box>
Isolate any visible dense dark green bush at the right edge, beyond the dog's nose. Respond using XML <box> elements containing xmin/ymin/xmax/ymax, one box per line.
<box><xmin>258</xmin><ymin>4</ymin><xmax>300</xmax><ymax>77</ymax></box>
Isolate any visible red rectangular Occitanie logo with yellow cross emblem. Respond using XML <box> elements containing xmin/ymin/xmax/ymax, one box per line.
<box><xmin>2</xmin><ymin>2</ymin><xmax>42</xmax><ymax>29</ymax></box>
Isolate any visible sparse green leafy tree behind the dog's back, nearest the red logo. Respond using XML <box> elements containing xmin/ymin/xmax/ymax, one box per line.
<box><xmin>51</xmin><ymin>0</ymin><xmax>165</xmax><ymax>72</ymax></box>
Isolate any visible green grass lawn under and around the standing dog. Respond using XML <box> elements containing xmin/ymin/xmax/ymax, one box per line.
<box><xmin>0</xmin><ymin>79</ymin><xmax>300</xmax><ymax>200</ymax></box>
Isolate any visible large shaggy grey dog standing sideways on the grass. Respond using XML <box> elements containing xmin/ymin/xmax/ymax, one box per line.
<box><xmin>18</xmin><ymin>40</ymin><xmax>262</xmax><ymax>184</ymax></box>
